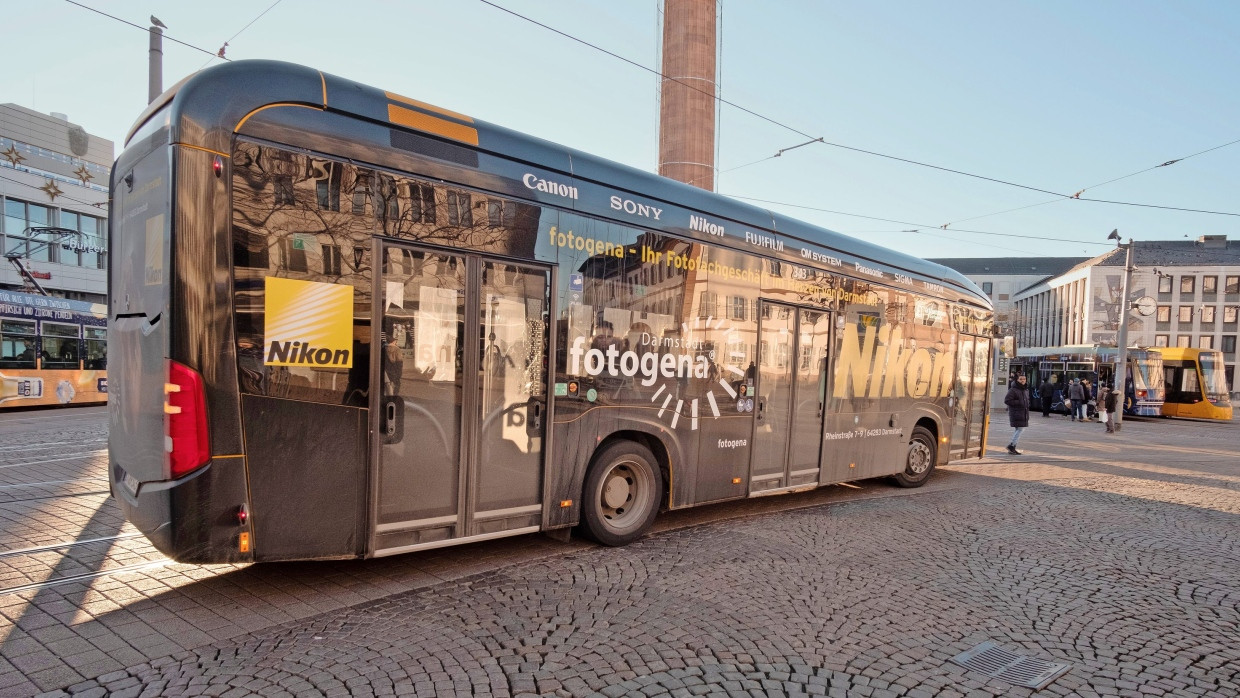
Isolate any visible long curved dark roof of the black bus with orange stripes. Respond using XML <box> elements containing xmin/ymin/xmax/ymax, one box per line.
<box><xmin>126</xmin><ymin>61</ymin><xmax>992</xmax><ymax>310</ymax></box>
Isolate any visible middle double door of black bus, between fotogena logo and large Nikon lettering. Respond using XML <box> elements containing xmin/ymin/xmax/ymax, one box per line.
<box><xmin>749</xmin><ymin>301</ymin><xmax>831</xmax><ymax>495</ymax></box>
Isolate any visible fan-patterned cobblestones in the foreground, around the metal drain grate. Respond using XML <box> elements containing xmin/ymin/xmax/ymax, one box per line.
<box><xmin>21</xmin><ymin>480</ymin><xmax>1240</xmax><ymax>697</ymax></box>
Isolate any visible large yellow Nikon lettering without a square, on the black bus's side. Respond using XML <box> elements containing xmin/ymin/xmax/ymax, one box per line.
<box><xmin>832</xmin><ymin>325</ymin><xmax>955</xmax><ymax>398</ymax></box>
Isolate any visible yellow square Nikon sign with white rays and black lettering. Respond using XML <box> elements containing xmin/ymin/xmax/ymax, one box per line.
<box><xmin>263</xmin><ymin>276</ymin><xmax>353</xmax><ymax>368</ymax></box>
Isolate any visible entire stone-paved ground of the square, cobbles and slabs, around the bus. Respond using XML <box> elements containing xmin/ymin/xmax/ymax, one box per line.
<box><xmin>0</xmin><ymin>406</ymin><xmax>1240</xmax><ymax>697</ymax></box>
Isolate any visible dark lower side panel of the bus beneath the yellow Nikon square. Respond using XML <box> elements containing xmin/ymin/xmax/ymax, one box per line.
<box><xmin>242</xmin><ymin>394</ymin><xmax>368</xmax><ymax>562</ymax></box>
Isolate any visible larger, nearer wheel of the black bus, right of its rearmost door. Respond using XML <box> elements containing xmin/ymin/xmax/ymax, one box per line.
<box><xmin>582</xmin><ymin>441</ymin><xmax>663</xmax><ymax>546</ymax></box>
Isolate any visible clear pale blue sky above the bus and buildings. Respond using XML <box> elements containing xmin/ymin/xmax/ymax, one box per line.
<box><xmin>7</xmin><ymin>0</ymin><xmax>1240</xmax><ymax>257</ymax></box>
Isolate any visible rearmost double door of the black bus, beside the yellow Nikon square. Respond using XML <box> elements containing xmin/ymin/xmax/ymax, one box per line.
<box><xmin>372</xmin><ymin>242</ymin><xmax>551</xmax><ymax>555</ymax></box>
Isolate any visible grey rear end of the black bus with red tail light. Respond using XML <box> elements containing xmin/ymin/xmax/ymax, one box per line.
<box><xmin>108</xmin><ymin>107</ymin><xmax>248</xmax><ymax>562</ymax></box>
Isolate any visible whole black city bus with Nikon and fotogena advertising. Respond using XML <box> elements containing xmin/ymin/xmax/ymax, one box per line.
<box><xmin>109</xmin><ymin>62</ymin><xmax>992</xmax><ymax>563</ymax></box>
